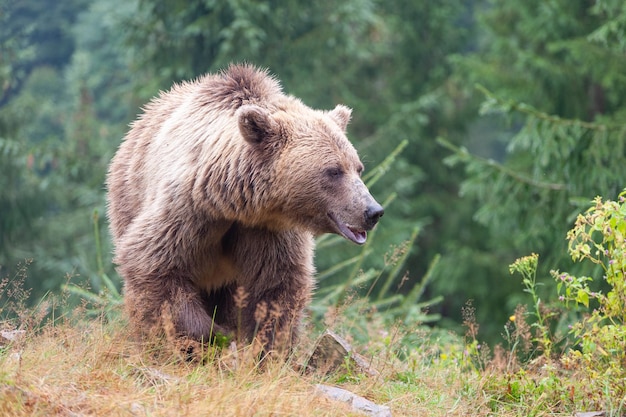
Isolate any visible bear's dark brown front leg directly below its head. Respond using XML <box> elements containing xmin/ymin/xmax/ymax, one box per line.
<box><xmin>229</xmin><ymin>227</ymin><xmax>314</xmax><ymax>353</ymax></box>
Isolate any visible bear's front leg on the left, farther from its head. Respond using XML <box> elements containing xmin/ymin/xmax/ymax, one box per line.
<box><xmin>115</xmin><ymin>212</ymin><xmax>229</xmax><ymax>342</ymax></box>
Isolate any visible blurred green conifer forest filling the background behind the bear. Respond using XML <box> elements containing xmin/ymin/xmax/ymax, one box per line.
<box><xmin>0</xmin><ymin>0</ymin><xmax>626</xmax><ymax>341</ymax></box>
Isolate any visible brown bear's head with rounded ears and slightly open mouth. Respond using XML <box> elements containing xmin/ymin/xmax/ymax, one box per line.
<box><xmin>237</xmin><ymin>98</ymin><xmax>384</xmax><ymax>244</ymax></box>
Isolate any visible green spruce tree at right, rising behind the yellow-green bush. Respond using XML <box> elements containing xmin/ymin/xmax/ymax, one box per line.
<box><xmin>438</xmin><ymin>0</ymin><xmax>626</xmax><ymax>340</ymax></box>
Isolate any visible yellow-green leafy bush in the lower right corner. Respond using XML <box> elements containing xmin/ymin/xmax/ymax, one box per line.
<box><xmin>486</xmin><ymin>190</ymin><xmax>626</xmax><ymax>416</ymax></box>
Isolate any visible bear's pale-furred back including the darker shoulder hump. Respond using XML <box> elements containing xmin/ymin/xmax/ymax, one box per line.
<box><xmin>107</xmin><ymin>65</ymin><xmax>289</xmax><ymax>239</ymax></box>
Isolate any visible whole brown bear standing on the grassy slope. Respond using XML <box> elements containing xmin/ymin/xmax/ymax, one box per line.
<box><xmin>107</xmin><ymin>65</ymin><xmax>383</xmax><ymax>350</ymax></box>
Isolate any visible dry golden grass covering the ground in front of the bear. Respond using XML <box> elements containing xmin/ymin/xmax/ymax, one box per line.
<box><xmin>0</xmin><ymin>308</ymin><xmax>488</xmax><ymax>417</ymax></box>
